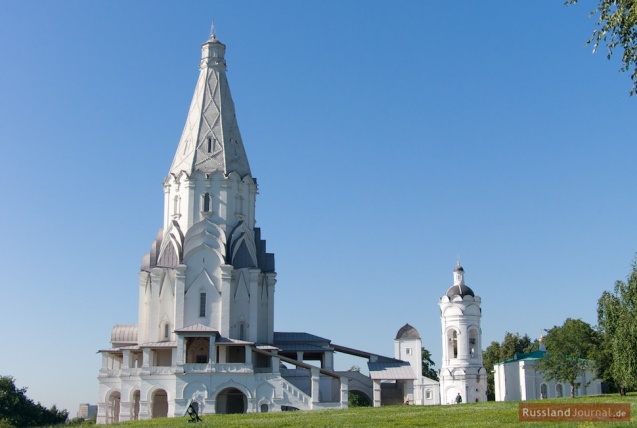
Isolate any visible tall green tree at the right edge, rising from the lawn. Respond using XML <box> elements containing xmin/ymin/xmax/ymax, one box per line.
<box><xmin>597</xmin><ymin>258</ymin><xmax>637</xmax><ymax>395</ymax></box>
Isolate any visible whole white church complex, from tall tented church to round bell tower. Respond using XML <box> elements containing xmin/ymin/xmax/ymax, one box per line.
<box><xmin>97</xmin><ymin>35</ymin><xmax>486</xmax><ymax>424</ymax></box>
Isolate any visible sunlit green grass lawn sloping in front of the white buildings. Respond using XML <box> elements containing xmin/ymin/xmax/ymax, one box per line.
<box><xmin>112</xmin><ymin>394</ymin><xmax>637</xmax><ymax>428</ymax></box>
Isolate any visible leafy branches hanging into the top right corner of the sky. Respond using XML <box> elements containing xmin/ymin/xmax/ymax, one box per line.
<box><xmin>566</xmin><ymin>0</ymin><xmax>637</xmax><ymax>95</ymax></box>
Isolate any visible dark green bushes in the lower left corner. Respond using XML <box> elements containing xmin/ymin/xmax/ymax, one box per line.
<box><xmin>0</xmin><ymin>376</ymin><xmax>68</xmax><ymax>427</ymax></box>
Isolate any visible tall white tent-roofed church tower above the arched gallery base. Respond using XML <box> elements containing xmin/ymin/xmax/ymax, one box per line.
<box><xmin>138</xmin><ymin>35</ymin><xmax>276</xmax><ymax>343</ymax></box>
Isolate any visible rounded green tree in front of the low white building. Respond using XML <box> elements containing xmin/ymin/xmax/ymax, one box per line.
<box><xmin>538</xmin><ymin>318</ymin><xmax>600</xmax><ymax>397</ymax></box>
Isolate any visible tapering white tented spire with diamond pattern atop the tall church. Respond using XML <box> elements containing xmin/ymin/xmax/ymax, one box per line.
<box><xmin>170</xmin><ymin>34</ymin><xmax>251</xmax><ymax>177</ymax></box>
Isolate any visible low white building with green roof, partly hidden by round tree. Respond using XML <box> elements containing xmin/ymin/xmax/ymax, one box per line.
<box><xmin>493</xmin><ymin>343</ymin><xmax>602</xmax><ymax>401</ymax></box>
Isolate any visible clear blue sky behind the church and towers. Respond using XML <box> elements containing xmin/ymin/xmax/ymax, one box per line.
<box><xmin>0</xmin><ymin>0</ymin><xmax>637</xmax><ymax>416</ymax></box>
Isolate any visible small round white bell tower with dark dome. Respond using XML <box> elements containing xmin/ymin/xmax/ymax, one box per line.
<box><xmin>438</xmin><ymin>262</ymin><xmax>487</xmax><ymax>404</ymax></box>
